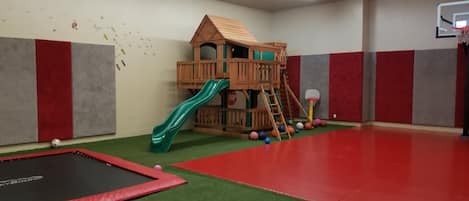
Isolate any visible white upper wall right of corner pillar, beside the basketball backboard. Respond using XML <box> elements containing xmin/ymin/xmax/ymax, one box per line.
<box><xmin>368</xmin><ymin>0</ymin><xmax>457</xmax><ymax>51</ymax></box>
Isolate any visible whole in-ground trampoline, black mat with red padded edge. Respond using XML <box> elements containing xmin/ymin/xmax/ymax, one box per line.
<box><xmin>0</xmin><ymin>149</ymin><xmax>186</xmax><ymax>201</ymax></box>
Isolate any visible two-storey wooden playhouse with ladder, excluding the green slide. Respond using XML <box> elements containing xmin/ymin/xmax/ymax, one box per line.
<box><xmin>177</xmin><ymin>15</ymin><xmax>299</xmax><ymax>139</ymax></box>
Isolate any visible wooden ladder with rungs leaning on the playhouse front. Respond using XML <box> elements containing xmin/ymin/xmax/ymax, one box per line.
<box><xmin>261</xmin><ymin>85</ymin><xmax>291</xmax><ymax>141</ymax></box>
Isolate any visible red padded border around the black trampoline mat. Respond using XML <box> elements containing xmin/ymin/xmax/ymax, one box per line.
<box><xmin>0</xmin><ymin>149</ymin><xmax>187</xmax><ymax>201</ymax></box>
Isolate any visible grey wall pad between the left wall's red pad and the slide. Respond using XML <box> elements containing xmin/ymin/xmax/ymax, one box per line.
<box><xmin>72</xmin><ymin>43</ymin><xmax>116</xmax><ymax>137</ymax></box>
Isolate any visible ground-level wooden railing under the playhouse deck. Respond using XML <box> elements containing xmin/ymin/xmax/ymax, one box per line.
<box><xmin>195</xmin><ymin>106</ymin><xmax>272</xmax><ymax>131</ymax></box>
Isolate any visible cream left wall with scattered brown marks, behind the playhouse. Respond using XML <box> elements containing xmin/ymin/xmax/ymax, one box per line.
<box><xmin>0</xmin><ymin>0</ymin><xmax>271</xmax><ymax>152</ymax></box>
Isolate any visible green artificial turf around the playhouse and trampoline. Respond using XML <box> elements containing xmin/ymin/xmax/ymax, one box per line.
<box><xmin>0</xmin><ymin>125</ymin><xmax>349</xmax><ymax>201</ymax></box>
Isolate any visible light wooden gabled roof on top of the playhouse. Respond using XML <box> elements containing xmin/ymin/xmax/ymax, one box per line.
<box><xmin>191</xmin><ymin>15</ymin><xmax>258</xmax><ymax>44</ymax></box>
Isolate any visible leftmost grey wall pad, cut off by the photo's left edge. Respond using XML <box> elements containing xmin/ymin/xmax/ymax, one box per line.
<box><xmin>0</xmin><ymin>38</ymin><xmax>37</xmax><ymax>145</ymax></box>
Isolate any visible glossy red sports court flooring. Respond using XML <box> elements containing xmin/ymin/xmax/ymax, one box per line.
<box><xmin>175</xmin><ymin>127</ymin><xmax>469</xmax><ymax>201</ymax></box>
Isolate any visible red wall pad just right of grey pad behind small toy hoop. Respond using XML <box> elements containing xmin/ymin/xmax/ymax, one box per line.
<box><xmin>329</xmin><ymin>52</ymin><xmax>363</xmax><ymax>122</ymax></box>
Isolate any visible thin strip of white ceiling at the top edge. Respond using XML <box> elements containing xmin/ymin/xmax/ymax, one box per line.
<box><xmin>220</xmin><ymin>0</ymin><xmax>337</xmax><ymax>11</ymax></box>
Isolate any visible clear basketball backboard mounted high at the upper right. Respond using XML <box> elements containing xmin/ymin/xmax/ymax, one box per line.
<box><xmin>436</xmin><ymin>0</ymin><xmax>469</xmax><ymax>38</ymax></box>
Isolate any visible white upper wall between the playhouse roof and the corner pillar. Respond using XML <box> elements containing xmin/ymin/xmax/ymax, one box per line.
<box><xmin>272</xmin><ymin>0</ymin><xmax>363</xmax><ymax>55</ymax></box>
